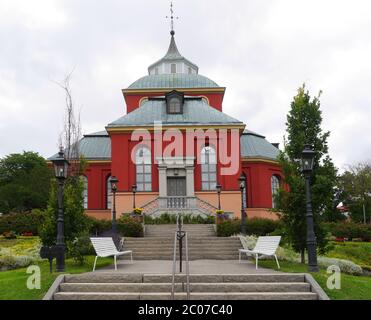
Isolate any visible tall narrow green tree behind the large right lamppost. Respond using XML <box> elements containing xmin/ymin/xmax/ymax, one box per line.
<box><xmin>276</xmin><ymin>85</ymin><xmax>336</xmax><ymax>262</ymax></box>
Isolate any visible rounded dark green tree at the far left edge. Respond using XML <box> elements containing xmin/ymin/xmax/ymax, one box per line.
<box><xmin>0</xmin><ymin>152</ymin><xmax>52</xmax><ymax>213</ymax></box>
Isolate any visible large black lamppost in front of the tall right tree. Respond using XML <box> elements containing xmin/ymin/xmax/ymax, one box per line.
<box><xmin>301</xmin><ymin>144</ymin><xmax>319</xmax><ymax>272</ymax></box>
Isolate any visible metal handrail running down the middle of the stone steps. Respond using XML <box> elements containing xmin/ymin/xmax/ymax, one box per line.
<box><xmin>171</xmin><ymin>215</ymin><xmax>191</xmax><ymax>300</ymax></box>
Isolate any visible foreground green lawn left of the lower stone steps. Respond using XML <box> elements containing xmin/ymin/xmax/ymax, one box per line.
<box><xmin>0</xmin><ymin>256</ymin><xmax>113</xmax><ymax>300</ymax></box>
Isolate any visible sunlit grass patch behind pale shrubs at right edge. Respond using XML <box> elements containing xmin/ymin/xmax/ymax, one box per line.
<box><xmin>326</xmin><ymin>242</ymin><xmax>371</xmax><ymax>271</ymax></box>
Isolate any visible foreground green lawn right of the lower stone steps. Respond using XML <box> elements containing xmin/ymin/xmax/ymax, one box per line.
<box><xmin>259</xmin><ymin>260</ymin><xmax>371</xmax><ymax>300</ymax></box>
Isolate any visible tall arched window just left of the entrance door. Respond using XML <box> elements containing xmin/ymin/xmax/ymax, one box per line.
<box><xmin>135</xmin><ymin>147</ymin><xmax>152</xmax><ymax>191</ymax></box>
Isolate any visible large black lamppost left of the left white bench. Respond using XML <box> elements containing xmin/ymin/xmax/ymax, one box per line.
<box><xmin>51</xmin><ymin>148</ymin><xmax>69</xmax><ymax>272</ymax></box>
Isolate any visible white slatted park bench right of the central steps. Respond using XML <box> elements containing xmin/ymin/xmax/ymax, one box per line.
<box><xmin>238</xmin><ymin>236</ymin><xmax>281</xmax><ymax>269</ymax></box>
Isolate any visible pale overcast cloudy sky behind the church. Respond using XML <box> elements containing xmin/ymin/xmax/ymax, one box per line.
<box><xmin>0</xmin><ymin>0</ymin><xmax>371</xmax><ymax>168</ymax></box>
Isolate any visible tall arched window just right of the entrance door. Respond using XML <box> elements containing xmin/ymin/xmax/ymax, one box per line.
<box><xmin>201</xmin><ymin>146</ymin><xmax>216</xmax><ymax>191</ymax></box>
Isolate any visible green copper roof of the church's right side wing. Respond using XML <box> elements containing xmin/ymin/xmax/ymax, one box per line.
<box><xmin>241</xmin><ymin>130</ymin><xmax>279</xmax><ymax>160</ymax></box>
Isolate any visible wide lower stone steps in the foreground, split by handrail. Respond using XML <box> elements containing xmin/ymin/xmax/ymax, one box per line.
<box><xmin>44</xmin><ymin>272</ymin><xmax>328</xmax><ymax>300</ymax></box>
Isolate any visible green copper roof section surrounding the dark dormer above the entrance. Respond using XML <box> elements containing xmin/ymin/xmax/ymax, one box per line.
<box><xmin>108</xmin><ymin>99</ymin><xmax>243</xmax><ymax>127</ymax></box>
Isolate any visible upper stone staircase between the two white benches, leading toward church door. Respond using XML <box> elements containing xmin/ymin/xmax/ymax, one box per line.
<box><xmin>122</xmin><ymin>225</ymin><xmax>242</xmax><ymax>260</ymax></box>
